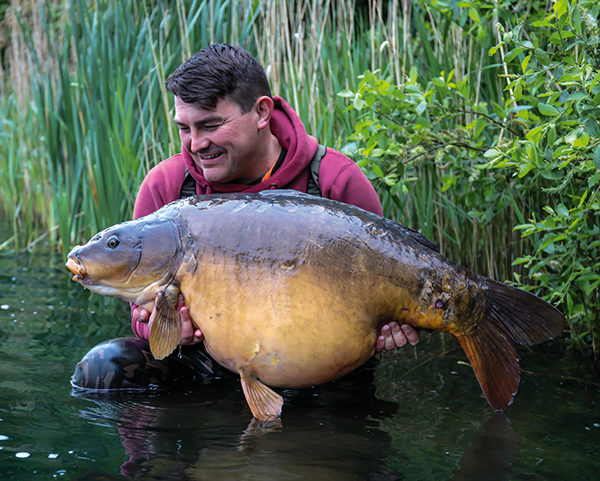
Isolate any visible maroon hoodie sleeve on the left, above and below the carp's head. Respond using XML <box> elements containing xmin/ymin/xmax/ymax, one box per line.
<box><xmin>131</xmin><ymin>154</ymin><xmax>185</xmax><ymax>340</ymax></box>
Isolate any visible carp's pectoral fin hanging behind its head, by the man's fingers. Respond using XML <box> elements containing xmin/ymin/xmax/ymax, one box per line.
<box><xmin>150</xmin><ymin>284</ymin><xmax>181</xmax><ymax>359</ymax></box>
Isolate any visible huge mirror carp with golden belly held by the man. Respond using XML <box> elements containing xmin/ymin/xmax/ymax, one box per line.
<box><xmin>67</xmin><ymin>191</ymin><xmax>565</xmax><ymax>420</ymax></box>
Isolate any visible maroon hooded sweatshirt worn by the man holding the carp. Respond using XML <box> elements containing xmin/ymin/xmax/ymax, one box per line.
<box><xmin>131</xmin><ymin>97</ymin><xmax>383</xmax><ymax>339</ymax></box>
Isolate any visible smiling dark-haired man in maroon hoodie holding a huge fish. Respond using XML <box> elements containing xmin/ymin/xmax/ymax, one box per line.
<box><xmin>73</xmin><ymin>44</ymin><xmax>419</xmax><ymax>389</ymax></box>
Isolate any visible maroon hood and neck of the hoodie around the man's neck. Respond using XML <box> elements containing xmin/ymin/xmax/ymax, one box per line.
<box><xmin>181</xmin><ymin>96</ymin><xmax>318</xmax><ymax>194</ymax></box>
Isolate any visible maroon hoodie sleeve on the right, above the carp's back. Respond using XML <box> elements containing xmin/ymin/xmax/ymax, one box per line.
<box><xmin>319</xmin><ymin>149</ymin><xmax>383</xmax><ymax>215</ymax></box>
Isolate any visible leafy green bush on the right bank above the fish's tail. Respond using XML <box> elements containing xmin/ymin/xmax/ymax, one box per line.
<box><xmin>339</xmin><ymin>0</ymin><xmax>600</xmax><ymax>356</ymax></box>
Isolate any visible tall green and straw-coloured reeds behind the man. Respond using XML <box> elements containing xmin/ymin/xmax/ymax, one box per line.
<box><xmin>0</xmin><ymin>0</ymin><xmax>560</xmax><ymax>278</ymax></box>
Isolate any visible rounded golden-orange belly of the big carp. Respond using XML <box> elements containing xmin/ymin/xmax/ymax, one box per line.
<box><xmin>181</xmin><ymin>262</ymin><xmax>390</xmax><ymax>388</ymax></box>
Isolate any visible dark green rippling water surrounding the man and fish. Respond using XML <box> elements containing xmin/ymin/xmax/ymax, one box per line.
<box><xmin>0</xmin><ymin>246</ymin><xmax>600</xmax><ymax>481</ymax></box>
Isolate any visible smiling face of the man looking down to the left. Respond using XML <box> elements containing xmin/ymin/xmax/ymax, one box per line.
<box><xmin>173</xmin><ymin>97</ymin><xmax>268</xmax><ymax>184</ymax></box>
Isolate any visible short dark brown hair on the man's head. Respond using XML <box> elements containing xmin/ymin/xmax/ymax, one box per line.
<box><xmin>165</xmin><ymin>43</ymin><xmax>272</xmax><ymax>113</ymax></box>
